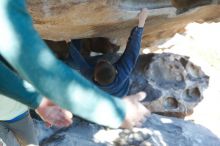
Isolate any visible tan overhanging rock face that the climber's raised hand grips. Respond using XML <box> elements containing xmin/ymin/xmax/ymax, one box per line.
<box><xmin>27</xmin><ymin>0</ymin><xmax>220</xmax><ymax>50</ymax></box>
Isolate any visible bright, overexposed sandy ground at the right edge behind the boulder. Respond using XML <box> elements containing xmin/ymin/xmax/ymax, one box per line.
<box><xmin>146</xmin><ymin>23</ymin><xmax>220</xmax><ymax>137</ymax></box>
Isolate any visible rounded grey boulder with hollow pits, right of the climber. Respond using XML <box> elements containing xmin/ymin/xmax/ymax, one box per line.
<box><xmin>129</xmin><ymin>53</ymin><xmax>209</xmax><ymax>117</ymax></box>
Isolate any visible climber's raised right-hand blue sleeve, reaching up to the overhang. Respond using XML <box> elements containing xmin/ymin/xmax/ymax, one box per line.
<box><xmin>115</xmin><ymin>27</ymin><xmax>143</xmax><ymax>79</ymax></box>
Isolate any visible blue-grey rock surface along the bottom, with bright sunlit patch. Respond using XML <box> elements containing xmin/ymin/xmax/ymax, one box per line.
<box><xmin>36</xmin><ymin>115</ymin><xmax>220</xmax><ymax>146</ymax></box>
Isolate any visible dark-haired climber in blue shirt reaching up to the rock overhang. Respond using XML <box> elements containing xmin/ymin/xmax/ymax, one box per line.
<box><xmin>65</xmin><ymin>9</ymin><xmax>148</xmax><ymax>97</ymax></box>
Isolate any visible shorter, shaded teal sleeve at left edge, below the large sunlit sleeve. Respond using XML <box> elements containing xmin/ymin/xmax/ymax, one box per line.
<box><xmin>0</xmin><ymin>62</ymin><xmax>42</xmax><ymax>109</ymax></box>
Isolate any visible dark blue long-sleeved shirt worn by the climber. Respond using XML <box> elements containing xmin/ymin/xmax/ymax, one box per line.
<box><xmin>66</xmin><ymin>27</ymin><xmax>143</xmax><ymax>97</ymax></box>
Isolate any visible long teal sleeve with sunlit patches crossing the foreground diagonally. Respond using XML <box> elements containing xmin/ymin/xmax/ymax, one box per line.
<box><xmin>0</xmin><ymin>0</ymin><xmax>126</xmax><ymax>128</ymax></box>
